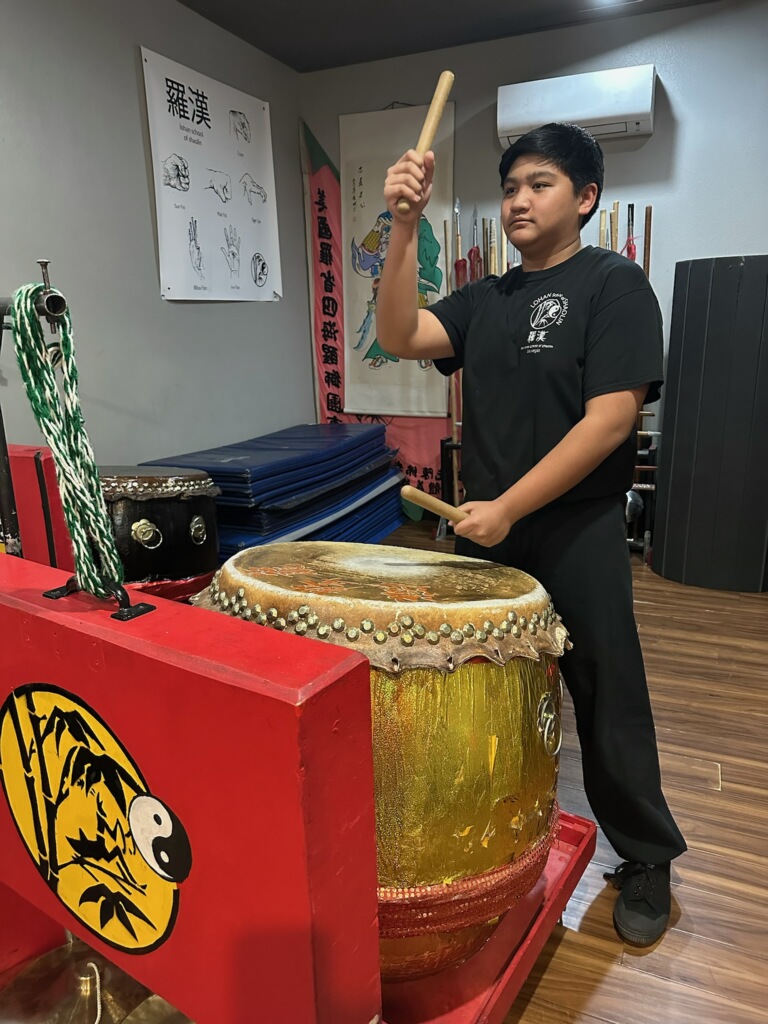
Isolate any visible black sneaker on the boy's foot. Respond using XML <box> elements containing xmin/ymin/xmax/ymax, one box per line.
<box><xmin>603</xmin><ymin>861</ymin><xmax>672</xmax><ymax>946</ymax></box>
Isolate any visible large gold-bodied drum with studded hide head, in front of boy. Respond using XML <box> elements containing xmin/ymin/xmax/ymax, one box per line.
<box><xmin>196</xmin><ymin>542</ymin><xmax>567</xmax><ymax>980</ymax></box>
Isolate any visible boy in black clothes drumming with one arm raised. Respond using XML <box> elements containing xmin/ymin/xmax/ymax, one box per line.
<box><xmin>376</xmin><ymin>124</ymin><xmax>686</xmax><ymax>946</ymax></box>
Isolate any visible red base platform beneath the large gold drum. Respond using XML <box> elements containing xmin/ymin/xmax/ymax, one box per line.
<box><xmin>382</xmin><ymin>811</ymin><xmax>597</xmax><ymax>1024</ymax></box>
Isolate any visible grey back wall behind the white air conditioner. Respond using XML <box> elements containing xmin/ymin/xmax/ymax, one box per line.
<box><xmin>301</xmin><ymin>0</ymin><xmax>768</xmax><ymax>407</ymax></box>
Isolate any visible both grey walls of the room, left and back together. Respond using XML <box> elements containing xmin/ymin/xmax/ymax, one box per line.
<box><xmin>0</xmin><ymin>0</ymin><xmax>768</xmax><ymax>463</ymax></box>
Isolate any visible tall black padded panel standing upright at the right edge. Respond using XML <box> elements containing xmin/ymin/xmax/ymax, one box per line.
<box><xmin>653</xmin><ymin>256</ymin><xmax>768</xmax><ymax>592</ymax></box>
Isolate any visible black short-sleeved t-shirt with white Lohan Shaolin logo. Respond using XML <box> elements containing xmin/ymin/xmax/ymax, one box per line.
<box><xmin>429</xmin><ymin>246</ymin><xmax>664</xmax><ymax>502</ymax></box>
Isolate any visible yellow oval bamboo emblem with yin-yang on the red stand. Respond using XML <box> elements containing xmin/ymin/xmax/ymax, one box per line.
<box><xmin>0</xmin><ymin>683</ymin><xmax>191</xmax><ymax>953</ymax></box>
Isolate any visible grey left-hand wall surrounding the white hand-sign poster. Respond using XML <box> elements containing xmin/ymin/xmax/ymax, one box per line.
<box><xmin>0</xmin><ymin>0</ymin><xmax>314</xmax><ymax>464</ymax></box>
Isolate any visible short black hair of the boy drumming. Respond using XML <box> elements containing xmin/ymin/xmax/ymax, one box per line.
<box><xmin>499</xmin><ymin>122</ymin><xmax>605</xmax><ymax>227</ymax></box>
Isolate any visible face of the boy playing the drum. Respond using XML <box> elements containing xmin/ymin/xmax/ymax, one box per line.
<box><xmin>502</xmin><ymin>155</ymin><xmax>597</xmax><ymax>255</ymax></box>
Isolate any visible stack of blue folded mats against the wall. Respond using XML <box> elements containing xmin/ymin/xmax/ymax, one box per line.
<box><xmin>144</xmin><ymin>423</ymin><xmax>404</xmax><ymax>560</ymax></box>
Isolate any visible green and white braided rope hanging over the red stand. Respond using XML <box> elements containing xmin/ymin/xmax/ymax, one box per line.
<box><xmin>9</xmin><ymin>285</ymin><xmax>124</xmax><ymax>597</ymax></box>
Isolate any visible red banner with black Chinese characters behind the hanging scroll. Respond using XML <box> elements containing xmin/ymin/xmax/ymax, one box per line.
<box><xmin>301</xmin><ymin>124</ymin><xmax>451</xmax><ymax>500</ymax></box>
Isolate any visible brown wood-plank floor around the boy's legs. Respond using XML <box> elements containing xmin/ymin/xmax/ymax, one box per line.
<box><xmin>386</xmin><ymin>522</ymin><xmax>768</xmax><ymax>1024</ymax></box>
